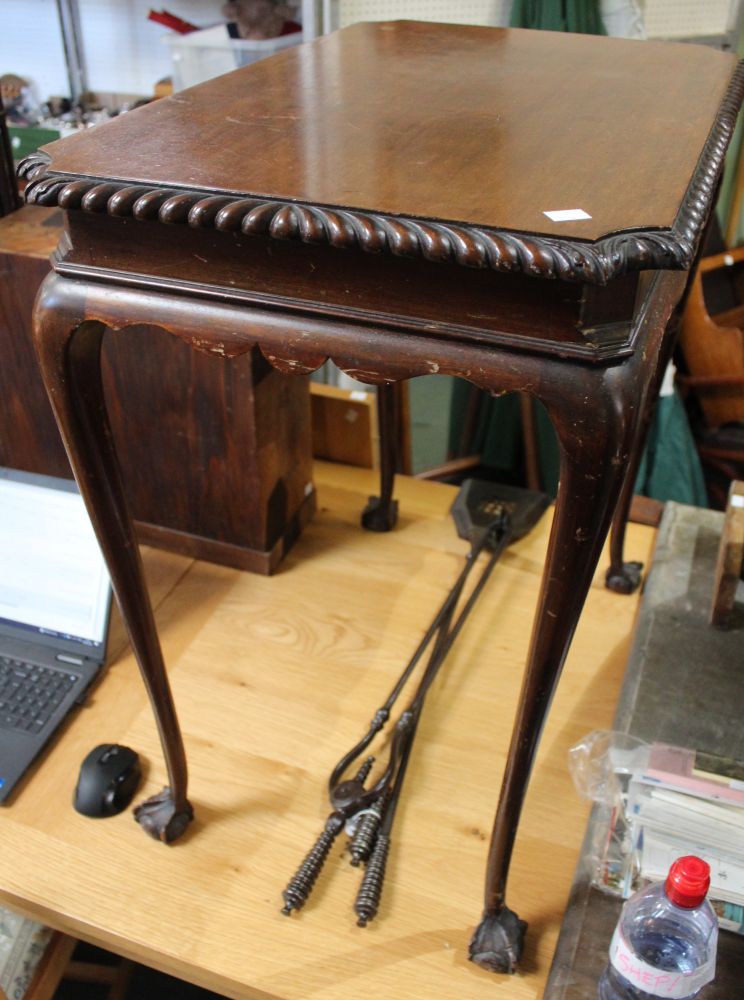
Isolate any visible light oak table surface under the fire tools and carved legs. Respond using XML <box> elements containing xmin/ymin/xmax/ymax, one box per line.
<box><xmin>0</xmin><ymin>465</ymin><xmax>654</xmax><ymax>1000</ymax></box>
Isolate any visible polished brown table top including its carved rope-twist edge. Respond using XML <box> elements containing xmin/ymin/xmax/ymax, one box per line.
<box><xmin>25</xmin><ymin>21</ymin><xmax>744</xmax><ymax>295</ymax></box>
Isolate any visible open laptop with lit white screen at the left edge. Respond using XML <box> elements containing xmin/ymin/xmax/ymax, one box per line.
<box><xmin>0</xmin><ymin>468</ymin><xmax>111</xmax><ymax>802</ymax></box>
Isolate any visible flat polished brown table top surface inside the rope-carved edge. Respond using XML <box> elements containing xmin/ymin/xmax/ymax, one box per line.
<box><xmin>36</xmin><ymin>21</ymin><xmax>736</xmax><ymax>240</ymax></box>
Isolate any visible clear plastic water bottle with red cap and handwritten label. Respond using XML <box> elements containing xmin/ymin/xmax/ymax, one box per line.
<box><xmin>597</xmin><ymin>855</ymin><xmax>718</xmax><ymax>1000</ymax></box>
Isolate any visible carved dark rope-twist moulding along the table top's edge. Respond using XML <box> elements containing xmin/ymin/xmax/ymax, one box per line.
<box><xmin>18</xmin><ymin>63</ymin><xmax>744</xmax><ymax>285</ymax></box>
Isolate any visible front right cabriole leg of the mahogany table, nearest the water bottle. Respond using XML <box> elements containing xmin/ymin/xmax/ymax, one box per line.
<box><xmin>470</xmin><ymin>380</ymin><xmax>634</xmax><ymax>973</ymax></box>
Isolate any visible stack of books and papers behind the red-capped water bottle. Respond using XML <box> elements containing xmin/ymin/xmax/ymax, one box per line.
<box><xmin>624</xmin><ymin>743</ymin><xmax>744</xmax><ymax>933</ymax></box>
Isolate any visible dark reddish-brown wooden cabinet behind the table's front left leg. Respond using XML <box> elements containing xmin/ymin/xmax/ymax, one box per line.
<box><xmin>0</xmin><ymin>205</ymin><xmax>315</xmax><ymax>573</ymax></box>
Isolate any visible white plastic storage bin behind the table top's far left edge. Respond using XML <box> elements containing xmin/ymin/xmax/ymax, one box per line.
<box><xmin>166</xmin><ymin>24</ymin><xmax>302</xmax><ymax>90</ymax></box>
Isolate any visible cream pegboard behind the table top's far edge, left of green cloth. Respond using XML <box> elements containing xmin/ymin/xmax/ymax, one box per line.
<box><xmin>332</xmin><ymin>0</ymin><xmax>512</xmax><ymax>28</ymax></box>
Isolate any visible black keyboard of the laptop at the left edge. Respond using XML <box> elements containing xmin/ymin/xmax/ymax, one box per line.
<box><xmin>0</xmin><ymin>656</ymin><xmax>80</xmax><ymax>733</ymax></box>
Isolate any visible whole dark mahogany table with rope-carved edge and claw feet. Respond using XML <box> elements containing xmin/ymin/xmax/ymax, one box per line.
<box><xmin>17</xmin><ymin>22</ymin><xmax>744</xmax><ymax>971</ymax></box>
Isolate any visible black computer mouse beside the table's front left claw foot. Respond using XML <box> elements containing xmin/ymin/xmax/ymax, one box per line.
<box><xmin>73</xmin><ymin>743</ymin><xmax>142</xmax><ymax>818</ymax></box>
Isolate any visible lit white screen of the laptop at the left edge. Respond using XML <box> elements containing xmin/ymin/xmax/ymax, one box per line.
<box><xmin>0</xmin><ymin>469</ymin><xmax>110</xmax><ymax>652</ymax></box>
